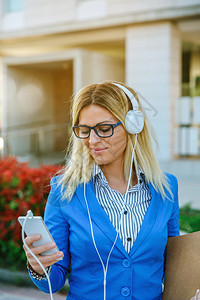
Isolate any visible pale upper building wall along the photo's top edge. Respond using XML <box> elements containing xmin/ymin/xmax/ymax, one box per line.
<box><xmin>0</xmin><ymin>0</ymin><xmax>200</xmax><ymax>32</ymax></box>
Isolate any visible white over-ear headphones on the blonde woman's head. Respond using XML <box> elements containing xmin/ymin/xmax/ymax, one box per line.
<box><xmin>112</xmin><ymin>82</ymin><xmax>144</xmax><ymax>134</ymax></box>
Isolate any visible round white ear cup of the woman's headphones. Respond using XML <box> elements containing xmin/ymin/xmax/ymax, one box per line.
<box><xmin>125</xmin><ymin>110</ymin><xmax>144</xmax><ymax>134</ymax></box>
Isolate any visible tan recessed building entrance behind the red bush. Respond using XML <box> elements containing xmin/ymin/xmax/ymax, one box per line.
<box><xmin>4</xmin><ymin>61</ymin><xmax>73</xmax><ymax>154</ymax></box>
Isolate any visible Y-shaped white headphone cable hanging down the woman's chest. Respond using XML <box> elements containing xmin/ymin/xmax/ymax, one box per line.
<box><xmin>84</xmin><ymin>134</ymin><xmax>137</xmax><ymax>300</ymax></box>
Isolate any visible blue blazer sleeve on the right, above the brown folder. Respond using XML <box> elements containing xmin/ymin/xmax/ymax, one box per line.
<box><xmin>167</xmin><ymin>175</ymin><xmax>180</xmax><ymax>237</ymax></box>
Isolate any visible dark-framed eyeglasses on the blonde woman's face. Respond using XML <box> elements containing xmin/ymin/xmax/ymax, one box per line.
<box><xmin>72</xmin><ymin>122</ymin><xmax>122</xmax><ymax>139</ymax></box>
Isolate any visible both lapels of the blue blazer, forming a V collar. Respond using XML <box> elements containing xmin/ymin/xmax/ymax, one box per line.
<box><xmin>76</xmin><ymin>180</ymin><xmax>162</xmax><ymax>258</ymax></box>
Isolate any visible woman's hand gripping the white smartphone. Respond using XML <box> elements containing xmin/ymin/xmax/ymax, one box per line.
<box><xmin>23</xmin><ymin>234</ymin><xmax>64</xmax><ymax>275</ymax></box>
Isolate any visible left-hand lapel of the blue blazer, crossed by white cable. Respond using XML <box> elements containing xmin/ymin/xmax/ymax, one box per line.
<box><xmin>76</xmin><ymin>180</ymin><xmax>128</xmax><ymax>258</ymax></box>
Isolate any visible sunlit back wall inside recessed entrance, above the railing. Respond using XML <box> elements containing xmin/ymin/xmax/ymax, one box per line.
<box><xmin>7</xmin><ymin>67</ymin><xmax>53</xmax><ymax>127</ymax></box>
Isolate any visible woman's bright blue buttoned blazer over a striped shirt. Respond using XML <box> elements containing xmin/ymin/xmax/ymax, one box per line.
<box><xmin>29</xmin><ymin>174</ymin><xmax>179</xmax><ymax>300</ymax></box>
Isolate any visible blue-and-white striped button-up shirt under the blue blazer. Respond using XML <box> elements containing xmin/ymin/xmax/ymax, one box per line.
<box><xmin>93</xmin><ymin>164</ymin><xmax>151</xmax><ymax>253</ymax></box>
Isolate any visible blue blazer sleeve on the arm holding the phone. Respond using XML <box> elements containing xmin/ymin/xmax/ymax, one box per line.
<box><xmin>29</xmin><ymin>177</ymin><xmax>70</xmax><ymax>293</ymax></box>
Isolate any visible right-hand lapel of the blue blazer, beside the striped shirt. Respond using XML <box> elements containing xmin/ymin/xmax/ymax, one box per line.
<box><xmin>129</xmin><ymin>184</ymin><xmax>162</xmax><ymax>256</ymax></box>
